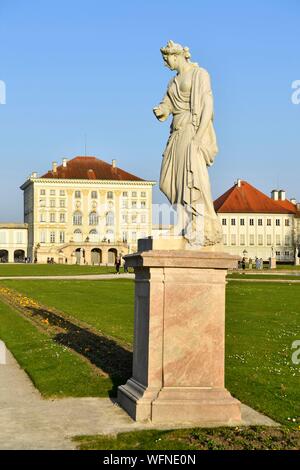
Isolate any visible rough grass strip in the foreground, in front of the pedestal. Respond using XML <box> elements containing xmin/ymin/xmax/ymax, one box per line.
<box><xmin>74</xmin><ymin>426</ymin><xmax>300</xmax><ymax>451</ymax></box>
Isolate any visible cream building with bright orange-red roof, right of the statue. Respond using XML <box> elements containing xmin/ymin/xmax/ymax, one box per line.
<box><xmin>214</xmin><ymin>179</ymin><xmax>300</xmax><ymax>262</ymax></box>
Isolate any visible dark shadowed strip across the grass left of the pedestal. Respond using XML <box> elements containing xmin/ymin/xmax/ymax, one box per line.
<box><xmin>25</xmin><ymin>307</ymin><xmax>132</xmax><ymax>397</ymax></box>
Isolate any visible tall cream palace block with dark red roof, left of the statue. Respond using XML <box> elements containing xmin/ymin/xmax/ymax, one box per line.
<box><xmin>21</xmin><ymin>156</ymin><xmax>155</xmax><ymax>264</ymax></box>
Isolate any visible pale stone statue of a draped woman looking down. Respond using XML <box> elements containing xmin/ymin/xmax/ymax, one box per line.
<box><xmin>153</xmin><ymin>41</ymin><xmax>222</xmax><ymax>246</ymax></box>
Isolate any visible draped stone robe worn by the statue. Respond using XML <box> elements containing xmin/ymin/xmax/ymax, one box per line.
<box><xmin>160</xmin><ymin>65</ymin><xmax>222</xmax><ymax>245</ymax></box>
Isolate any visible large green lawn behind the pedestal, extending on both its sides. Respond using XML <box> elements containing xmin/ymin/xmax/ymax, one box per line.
<box><xmin>0</xmin><ymin>280</ymin><xmax>300</xmax><ymax>426</ymax></box>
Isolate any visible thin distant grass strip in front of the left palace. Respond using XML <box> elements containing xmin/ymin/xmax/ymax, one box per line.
<box><xmin>0</xmin><ymin>263</ymin><xmax>118</xmax><ymax>277</ymax></box>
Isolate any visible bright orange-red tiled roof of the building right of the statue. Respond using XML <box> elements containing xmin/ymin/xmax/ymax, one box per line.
<box><xmin>214</xmin><ymin>181</ymin><xmax>297</xmax><ymax>214</ymax></box>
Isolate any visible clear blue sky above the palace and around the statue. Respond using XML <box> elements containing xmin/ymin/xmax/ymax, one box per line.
<box><xmin>0</xmin><ymin>0</ymin><xmax>300</xmax><ymax>221</ymax></box>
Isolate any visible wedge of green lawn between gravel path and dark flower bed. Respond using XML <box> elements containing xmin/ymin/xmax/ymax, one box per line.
<box><xmin>0</xmin><ymin>302</ymin><xmax>112</xmax><ymax>398</ymax></box>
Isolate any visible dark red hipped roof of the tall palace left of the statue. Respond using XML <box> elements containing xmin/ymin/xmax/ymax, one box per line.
<box><xmin>41</xmin><ymin>157</ymin><xmax>144</xmax><ymax>181</ymax></box>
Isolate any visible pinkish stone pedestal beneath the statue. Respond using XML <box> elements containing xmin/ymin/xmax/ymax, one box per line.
<box><xmin>118</xmin><ymin>246</ymin><xmax>241</xmax><ymax>425</ymax></box>
